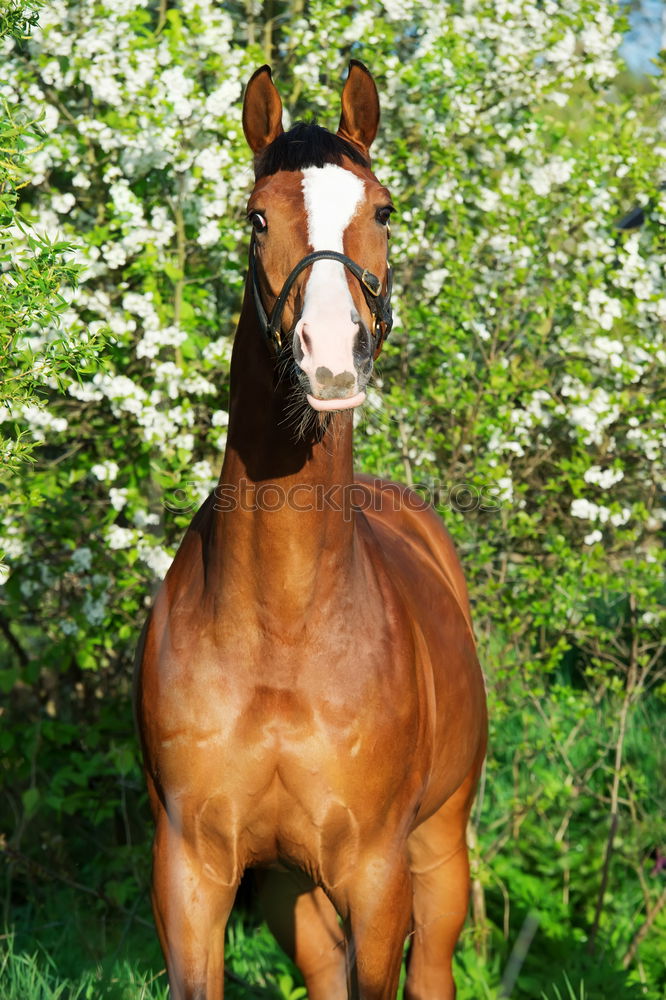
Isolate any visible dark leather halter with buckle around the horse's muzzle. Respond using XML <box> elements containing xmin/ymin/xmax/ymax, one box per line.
<box><xmin>250</xmin><ymin>236</ymin><xmax>393</xmax><ymax>354</ymax></box>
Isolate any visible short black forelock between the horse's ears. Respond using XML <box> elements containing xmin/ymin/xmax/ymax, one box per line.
<box><xmin>255</xmin><ymin>122</ymin><xmax>370</xmax><ymax>180</ymax></box>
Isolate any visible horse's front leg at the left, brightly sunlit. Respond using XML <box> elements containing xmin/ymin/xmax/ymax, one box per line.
<box><xmin>152</xmin><ymin>813</ymin><xmax>237</xmax><ymax>1000</ymax></box>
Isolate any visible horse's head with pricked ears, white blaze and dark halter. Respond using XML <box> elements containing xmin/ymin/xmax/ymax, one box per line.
<box><xmin>243</xmin><ymin>61</ymin><xmax>392</xmax><ymax>410</ymax></box>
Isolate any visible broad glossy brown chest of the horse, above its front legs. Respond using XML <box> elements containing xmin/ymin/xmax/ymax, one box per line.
<box><xmin>143</xmin><ymin>584</ymin><xmax>426</xmax><ymax>864</ymax></box>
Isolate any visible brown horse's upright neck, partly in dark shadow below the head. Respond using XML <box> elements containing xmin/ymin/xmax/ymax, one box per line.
<box><xmin>212</xmin><ymin>297</ymin><xmax>354</xmax><ymax>627</ymax></box>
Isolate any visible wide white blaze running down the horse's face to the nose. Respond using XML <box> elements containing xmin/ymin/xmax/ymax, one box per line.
<box><xmin>296</xmin><ymin>164</ymin><xmax>365</xmax><ymax>396</ymax></box>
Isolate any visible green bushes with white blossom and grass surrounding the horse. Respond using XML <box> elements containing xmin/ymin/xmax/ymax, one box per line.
<box><xmin>0</xmin><ymin>0</ymin><xmax>666</xmax><ymax>1000</ymax></box>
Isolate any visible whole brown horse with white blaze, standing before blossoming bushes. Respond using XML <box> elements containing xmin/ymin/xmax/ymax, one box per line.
<box><xmin>137</xmin><ymin>62</ymin><xmax>486</xmax><ymax>1000</ymax></box>
